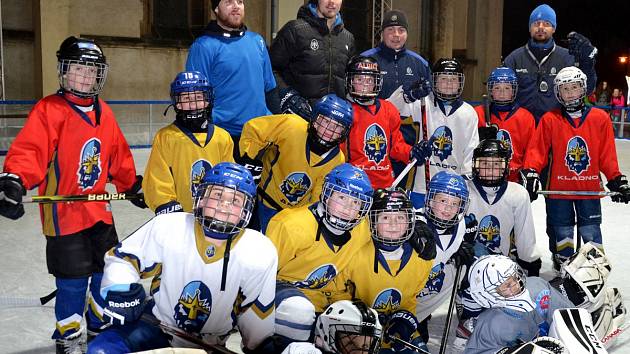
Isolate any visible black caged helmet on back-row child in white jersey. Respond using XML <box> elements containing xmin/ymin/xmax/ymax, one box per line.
<box><xmin>431</xmin><ymin>58</ymin><xmax>465</xmax><ymax>101</ymax></box>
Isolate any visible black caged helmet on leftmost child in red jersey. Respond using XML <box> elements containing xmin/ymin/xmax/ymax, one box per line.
<box><xmin>57</xmin><ymin>36</ymin><xmax>108</xmax><ymax>98</ymax></box>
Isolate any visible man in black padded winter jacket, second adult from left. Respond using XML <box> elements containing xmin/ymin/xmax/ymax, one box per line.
<box><xmin>269</xmin><ymin>0</ymin><xmax>355</xmax><ymax>118</ymax></box>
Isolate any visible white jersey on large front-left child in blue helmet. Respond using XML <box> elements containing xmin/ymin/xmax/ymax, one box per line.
<box><xmin>101</xmin><ymin>213</ymin><xmax>278</xmax><ymax>349</ymax></box>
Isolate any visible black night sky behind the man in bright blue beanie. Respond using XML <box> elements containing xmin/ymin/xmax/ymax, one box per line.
<box><xmin>503</xmin><ymin>0</ymin><xmax>630</xmax><ymax>92</ymax></box>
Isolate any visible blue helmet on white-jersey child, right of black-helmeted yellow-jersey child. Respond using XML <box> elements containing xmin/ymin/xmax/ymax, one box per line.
<box><xmin>424</xmin><ymin>171</ymin><xmax>469</xmax><ymax>229</ymax></box>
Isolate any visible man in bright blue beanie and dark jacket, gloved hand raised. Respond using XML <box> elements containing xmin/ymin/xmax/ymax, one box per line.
<box><xmin>504</xmin><ymin>4</ymin><xmax>597</xmax><ymax>122</ymax></box>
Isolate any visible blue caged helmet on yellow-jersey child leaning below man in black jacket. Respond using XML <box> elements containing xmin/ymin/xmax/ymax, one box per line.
<box><xmin>308</xmin><ymin>93</ymin><xmax>352</xmax><ymax>151</ymax></box>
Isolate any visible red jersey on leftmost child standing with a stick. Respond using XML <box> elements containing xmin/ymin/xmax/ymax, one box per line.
<box><xmin>4</xmin><ymin>94</ymin><xmax>136</xmax><ymax>236</ymax></box>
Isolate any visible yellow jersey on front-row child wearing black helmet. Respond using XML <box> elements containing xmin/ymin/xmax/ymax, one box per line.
<box><xmin>335</xmin><ymin>242</ymin><xmax>433</xmax><ymax>315</ymax></box>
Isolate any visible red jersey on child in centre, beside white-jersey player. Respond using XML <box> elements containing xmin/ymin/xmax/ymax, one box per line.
<box><xmin>341</xmin><ymin>99</ymin><xmax>411</xmax><ymax>188</ymax></box>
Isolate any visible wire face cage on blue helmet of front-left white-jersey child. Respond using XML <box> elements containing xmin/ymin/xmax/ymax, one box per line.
<box><xmin>194</xmin><ymin>183</ymin><xmax>254</xmax><ymax>238</ymax></box>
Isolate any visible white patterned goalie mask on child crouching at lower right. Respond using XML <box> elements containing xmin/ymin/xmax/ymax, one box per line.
<box><xmin>468</xmin><ymin>255</ymin><xmax>536</xmax><ymax>312</ymax></box>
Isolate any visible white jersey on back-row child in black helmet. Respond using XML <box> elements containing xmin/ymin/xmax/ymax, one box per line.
<box><xmin>411</xmin><ymin>94</ymin><xmax>479</xmax><ymax>194</ymax></box>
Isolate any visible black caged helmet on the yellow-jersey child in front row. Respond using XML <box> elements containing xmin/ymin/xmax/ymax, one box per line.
<box><xmin>369</xmin><ymin>188</ymin><xmax>415</xmax><ymax>251</ymax></box>
